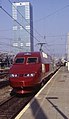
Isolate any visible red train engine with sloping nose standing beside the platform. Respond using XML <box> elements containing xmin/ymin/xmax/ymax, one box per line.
<box><xmin>9</xmin><ymin>52</ymin><xmax>51</xmax><ymax>94</ymax></box>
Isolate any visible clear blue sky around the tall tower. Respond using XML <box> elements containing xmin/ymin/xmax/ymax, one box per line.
<box><xmin>0</xmin><ymin>0</ymin><xmax>69</xmax><ymax>57</ymax></box>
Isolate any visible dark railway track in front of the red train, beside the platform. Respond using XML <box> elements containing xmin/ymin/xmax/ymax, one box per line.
<box><xmin>0</xmin><ymin>95</ymin><xmax>33</xmax><ymax>119</ymax></box>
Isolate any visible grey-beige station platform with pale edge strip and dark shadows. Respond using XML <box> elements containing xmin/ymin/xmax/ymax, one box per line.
<box><xmin>15</xmin><ymin>67</ymin><xmax>69</xmax><ymax>119</ymax></box>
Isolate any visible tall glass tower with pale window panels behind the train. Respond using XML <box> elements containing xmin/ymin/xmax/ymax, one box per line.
<box><xmin>12</xmin><ymin>2</ymin><xmax>34</xmax><ymax>52</ymax></box>
